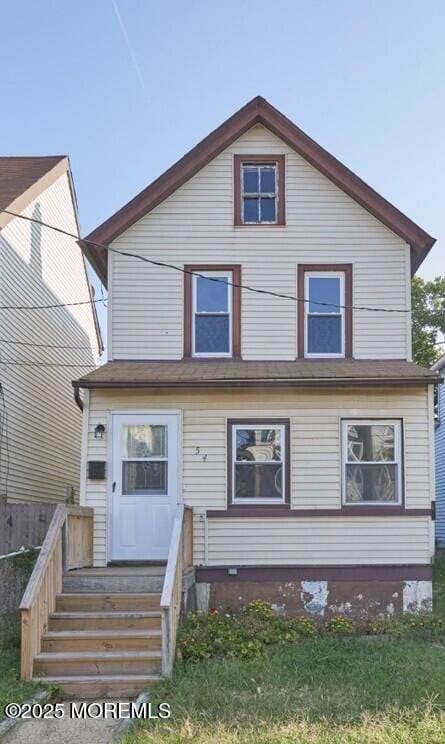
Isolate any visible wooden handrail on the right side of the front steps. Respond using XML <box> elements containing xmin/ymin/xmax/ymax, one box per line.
<box><xmin>161</xmin><ymin>504</ymin><xmax>193</xmax><ymax>676</ymax></box>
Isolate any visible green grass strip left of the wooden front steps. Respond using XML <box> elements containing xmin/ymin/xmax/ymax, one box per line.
<box><xmin>0</xmin><ymin>615</ymin><xmax>40</xmax><ymax>720</ymax></box>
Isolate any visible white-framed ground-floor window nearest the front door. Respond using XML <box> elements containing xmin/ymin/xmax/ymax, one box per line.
<box><xmin>228</xmin><ymin>420</ymin><xmax>290</xmax><ymax>505</ymax></box>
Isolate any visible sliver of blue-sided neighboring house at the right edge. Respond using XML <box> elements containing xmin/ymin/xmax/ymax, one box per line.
<box><xmin>431</xmin><ymin>354</ymin><xmax>445</xmax><ymax>548</ymax></box>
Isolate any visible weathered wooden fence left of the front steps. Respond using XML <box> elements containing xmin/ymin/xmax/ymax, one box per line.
<box><xmin>0</xmin><ymin>502</ymin><xmax>57</xmax><ymax>555</ymax></box>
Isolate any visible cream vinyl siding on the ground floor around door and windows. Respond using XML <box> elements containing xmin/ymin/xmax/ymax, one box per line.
<box><xmin>85</xmin><ymin>387</ymin><xmax>433</xmax><ymax>565</ymax></box>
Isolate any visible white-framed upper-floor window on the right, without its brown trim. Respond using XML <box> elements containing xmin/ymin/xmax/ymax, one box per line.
<box><xmin>304</xmin><ymin>271</ymin><xmax>345</xmax><ymax>357</ymax></box>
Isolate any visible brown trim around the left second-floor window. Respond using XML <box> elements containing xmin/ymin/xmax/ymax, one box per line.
<box><xmin>184</xmin><ymin>264</ymin><xmax>241</xmax><ymax>360</ymax></box>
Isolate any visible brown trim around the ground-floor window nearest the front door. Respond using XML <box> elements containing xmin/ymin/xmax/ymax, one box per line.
<box><xmin>227</xmin><ymin>417</ymin><xmax>291</xmax><ymax>506</ymax></box>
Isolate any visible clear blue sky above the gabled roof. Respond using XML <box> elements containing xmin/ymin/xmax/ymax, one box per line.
<box><xmin>0</xmin><ymin>0</ymin><xmax>445</xmax><ymax>342</ymax></box>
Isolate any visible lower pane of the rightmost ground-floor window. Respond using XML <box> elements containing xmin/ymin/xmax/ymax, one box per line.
<box><xmin>346</xmin><ymin>464</ymin><xmax>399</xmax><ymax>503</ymax></box>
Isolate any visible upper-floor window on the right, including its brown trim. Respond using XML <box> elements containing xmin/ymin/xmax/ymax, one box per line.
<box><xmin>298</xmin><ymin>264</ymin><xmax>352</xmax><ymax>359</ymax></box>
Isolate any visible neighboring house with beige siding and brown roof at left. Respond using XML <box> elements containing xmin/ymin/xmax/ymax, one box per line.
<box><xmin>0</xmin><ymin>156</ymin><xmax>101</xmax><ymax>502</ymax></box>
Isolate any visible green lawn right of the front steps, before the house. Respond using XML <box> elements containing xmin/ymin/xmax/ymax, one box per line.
<box><xmin>126</xmin><ymin>551</ymin><xmax>445</xmax><ymax>744</ymax></box>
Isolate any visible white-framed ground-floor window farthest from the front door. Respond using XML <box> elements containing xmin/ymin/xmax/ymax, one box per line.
<box><xmin>342</xmin><ymin>420</ymin><xmax>402</xmax><ymax>505</ymax></box>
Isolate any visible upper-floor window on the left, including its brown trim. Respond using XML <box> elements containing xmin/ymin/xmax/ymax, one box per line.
<box><xmin>184</xmin><ymin>265</ymin><xmax>241</xmax><ymax>357</ymax></box>
